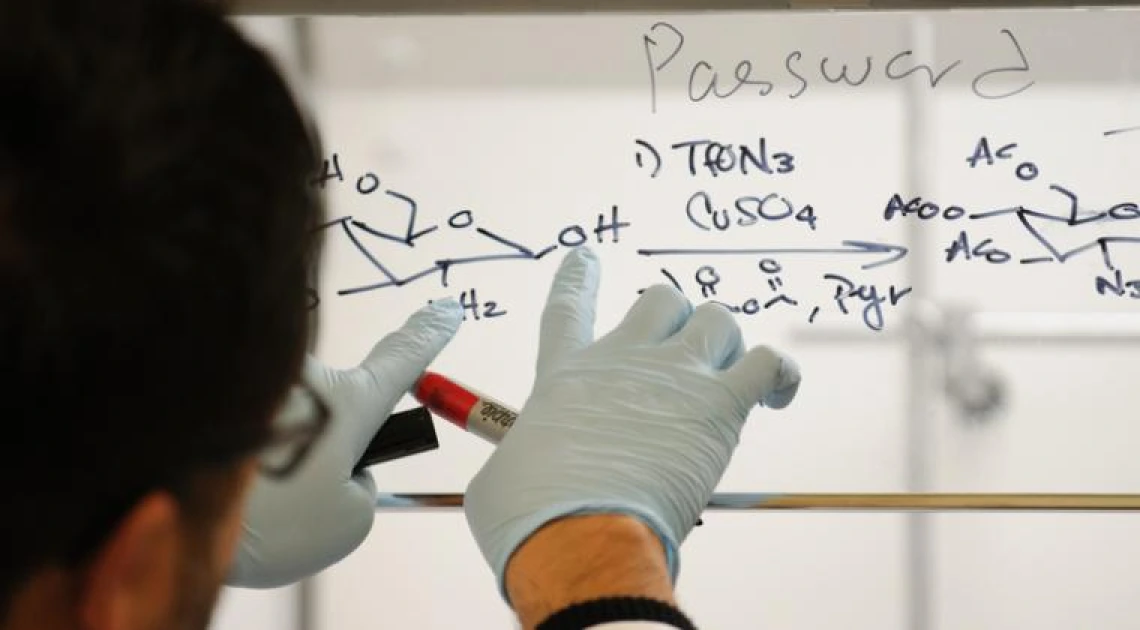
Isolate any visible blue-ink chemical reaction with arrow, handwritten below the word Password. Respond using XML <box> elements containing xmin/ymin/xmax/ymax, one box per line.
<box><xmin>314</xmin><ymin>125</ymin><xmax>1140</xmax><ymax>332</ymax></box>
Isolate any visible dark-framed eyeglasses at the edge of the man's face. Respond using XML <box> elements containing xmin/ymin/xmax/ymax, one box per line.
<box><xmin>259</xmin><ymin>381</ymin><xmax>332</xmax><ymax>480</ymax></box>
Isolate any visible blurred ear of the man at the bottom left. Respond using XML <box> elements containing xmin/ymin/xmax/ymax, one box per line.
<box><xmin>78</xmin><ymin>492</ymin><xmax>182</xmax><ymax>630</ymax></box>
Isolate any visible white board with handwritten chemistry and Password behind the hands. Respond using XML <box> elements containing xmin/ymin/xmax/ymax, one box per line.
<box><xmin>291</xmin><ymin>10</ymin><xmax>1140</xmax><ymax>630</ymax></box>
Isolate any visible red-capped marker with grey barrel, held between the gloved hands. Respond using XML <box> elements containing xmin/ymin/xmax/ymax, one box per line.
<box><xmin>413</xmin><ymin>371</ymin><xmax>519</xmax><ymax>444</ymax></box>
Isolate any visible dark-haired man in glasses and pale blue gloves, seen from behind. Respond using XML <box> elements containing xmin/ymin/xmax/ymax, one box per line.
<box><xmin>0</xmin><ymin>0</ymin><xmax>799</xmax><ymax>630</ymax></box>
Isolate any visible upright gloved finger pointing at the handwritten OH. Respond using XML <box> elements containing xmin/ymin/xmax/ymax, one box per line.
<box><xmin>537</xmin><ymin>247</ymin><xmax>601</xmax><ymax>374</ymax></box>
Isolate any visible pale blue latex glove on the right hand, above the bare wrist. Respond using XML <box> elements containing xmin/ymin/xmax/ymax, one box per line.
<box><xmin>464</xmin><ymin>247</ymin><xmax>800</xmax><ymax>598</ymax></box>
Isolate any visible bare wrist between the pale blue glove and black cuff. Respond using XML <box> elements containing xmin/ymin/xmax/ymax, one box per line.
<box><xmin>506</xmin><ymin>514</ymin><xmax>675</xmax><ymax>630</ymax></box>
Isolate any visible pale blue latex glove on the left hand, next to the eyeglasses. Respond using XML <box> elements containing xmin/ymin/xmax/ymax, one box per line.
<box><xmin>227</xmin><ymin>300</ymin><xmax>463</xmax><ymax>588</ymax></box>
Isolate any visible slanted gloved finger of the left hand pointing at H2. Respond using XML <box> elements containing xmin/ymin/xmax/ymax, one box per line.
<box><xmin>351</xmin><ymin>297</ymin><xmax>463</xmax><ymax>451</ymax></box>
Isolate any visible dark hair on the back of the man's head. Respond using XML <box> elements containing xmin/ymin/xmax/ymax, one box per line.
<box><xmin>0</xmin><ymin>0</ymin><xmax>321</xmax><ymax>617</ymax></box>
